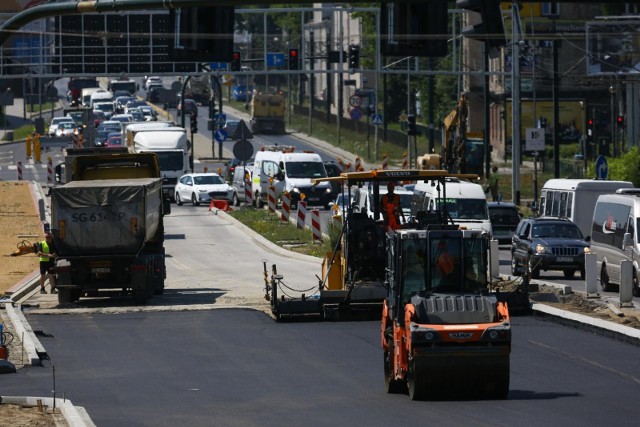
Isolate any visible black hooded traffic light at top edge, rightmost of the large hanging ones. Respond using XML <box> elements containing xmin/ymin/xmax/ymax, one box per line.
<box><xmin>456</xmin><ymin>0</ymin><xmax>507</xmax><ymax>49</ymax></box>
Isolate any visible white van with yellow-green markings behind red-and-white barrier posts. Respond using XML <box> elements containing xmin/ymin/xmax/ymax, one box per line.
<box><xmin>251</xmin><ymin>150</ymin><xmax>332</xmax><ymax>209</ymax></box>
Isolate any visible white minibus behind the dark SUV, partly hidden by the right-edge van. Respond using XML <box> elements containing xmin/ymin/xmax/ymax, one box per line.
<box><xmin>538</xmin><ymin>178</ymin><xmax>633</xmax><ymax>236</ymax></box>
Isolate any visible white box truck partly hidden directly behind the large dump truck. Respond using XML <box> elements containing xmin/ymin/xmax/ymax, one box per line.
<box><xmin>129</xmin><ymin>127</ymin><xmax>190</xmax><ymax>201</ymax></box>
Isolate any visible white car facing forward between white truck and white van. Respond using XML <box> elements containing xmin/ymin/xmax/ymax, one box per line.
<box><xmin>175</xmin><ymin>173</ymin><xmax>237</xmax><ymax>206</ymax></box>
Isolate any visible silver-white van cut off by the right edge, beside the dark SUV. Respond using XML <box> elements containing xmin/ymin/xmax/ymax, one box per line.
<box><xmin>591</xmin><ymin>188</ymin><xmax>640</xmax><ymax>296</ymax></box>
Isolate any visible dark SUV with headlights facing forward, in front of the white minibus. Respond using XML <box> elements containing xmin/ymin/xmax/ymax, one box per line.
<box><xmin>511</xmin><ymin>217</ymin><xmax>591</xmax><ymax>279</ymax></box>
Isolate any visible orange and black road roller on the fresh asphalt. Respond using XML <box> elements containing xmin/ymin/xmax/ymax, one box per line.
<box><xmin>381</xmin><ymin>224</ymin><xmax>511</xmax><ymax>400</ymax></box>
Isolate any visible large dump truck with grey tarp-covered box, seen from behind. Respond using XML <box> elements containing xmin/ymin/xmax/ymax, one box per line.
<box><xmin>50</xmin><ymin>153</ymin><xmax>170</xmax><ymax>304</ymax></box>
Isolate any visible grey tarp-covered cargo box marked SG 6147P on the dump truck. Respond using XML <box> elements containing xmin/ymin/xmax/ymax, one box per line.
<box><xmin>51</xmin><ymin>178</ymin><xmax>162</xmax><ymax>258</ymax></box>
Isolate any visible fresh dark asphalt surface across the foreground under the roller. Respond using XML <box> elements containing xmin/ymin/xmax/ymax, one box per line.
<box><xmin>2</xmin><ymin>310</ymin><xmax>640</xmax><ymax>427</ymax></box>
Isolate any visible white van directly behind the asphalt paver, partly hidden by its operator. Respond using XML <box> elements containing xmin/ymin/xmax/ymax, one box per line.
<box><xmin>411</xmin><ymin>177</ymin><xmax>493</xmax><ymax>235</ymax></box>
